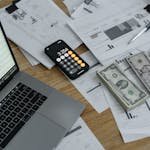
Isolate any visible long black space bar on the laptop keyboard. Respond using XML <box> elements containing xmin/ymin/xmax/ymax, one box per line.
<box><xmin>0</xmin><ymin>121</ymin><xmax>25</xmax><ymax>148</ymax></box>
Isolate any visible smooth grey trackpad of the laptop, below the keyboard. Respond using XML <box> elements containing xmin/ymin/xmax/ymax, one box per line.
<box><xmin>5</xmin><ymin>114</ymin><xmax>65</xmax><ymax>150</ymax></box>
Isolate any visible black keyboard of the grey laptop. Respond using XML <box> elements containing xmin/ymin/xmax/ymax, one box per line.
<box><xmin>0</xmin><ymin>83</ymin><xmax>47</xmax><ymax>148</ymax></box>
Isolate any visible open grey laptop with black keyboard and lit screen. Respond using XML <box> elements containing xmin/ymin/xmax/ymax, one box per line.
<box><xmin>0</xmin><ymin>24</ymin><xmax>84</xmax><ymax>150</ymax></box>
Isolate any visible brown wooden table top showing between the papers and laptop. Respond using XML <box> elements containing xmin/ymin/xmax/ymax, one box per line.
<box><xmin>0</xmin><ymin>0</ymin><xmax>150</xmax><ymax>150</ymax></box>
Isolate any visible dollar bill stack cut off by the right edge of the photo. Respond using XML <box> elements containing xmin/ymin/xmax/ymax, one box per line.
<box><xmin>126</xmin><ymin>52</ymin><xmax>150</xmax><ymax>92</ymax></box>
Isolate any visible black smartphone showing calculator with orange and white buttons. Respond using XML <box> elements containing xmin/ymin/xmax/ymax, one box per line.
<box><xmin>45</xmin><ymin>40</ymin><xmax>89</xmax><ymax>80</ymax></box>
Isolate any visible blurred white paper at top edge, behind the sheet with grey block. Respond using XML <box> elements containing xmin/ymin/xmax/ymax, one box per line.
<box><xmin>70</xmin><ymin>0</ymin><xmax>146</xmax><ymax>19</ymax></box>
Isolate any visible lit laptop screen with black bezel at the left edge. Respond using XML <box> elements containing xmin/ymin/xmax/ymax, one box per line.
<box><xmin>0</xmin><ymin>24</ymin><xmax>17</xmax><ymax>89</ymax></box>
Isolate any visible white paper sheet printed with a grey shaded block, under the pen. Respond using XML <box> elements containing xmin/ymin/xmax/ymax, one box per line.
<box><xmin>69</xmin><ymin>1</ymin><xmax>150</xmax><ymax>65</ymax></box>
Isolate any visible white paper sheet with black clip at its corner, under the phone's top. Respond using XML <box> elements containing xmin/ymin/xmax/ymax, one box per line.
<box><xmin>0</xmin><ymin>0</ymin><xmax>81</xmax><ymax>68</ymax></box>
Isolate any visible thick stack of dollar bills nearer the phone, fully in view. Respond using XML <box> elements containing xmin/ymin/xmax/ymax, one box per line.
<box><xmin>97</xmin><ymin>64</ymin><xmax>149</xmax><ymax>110</ymax></box>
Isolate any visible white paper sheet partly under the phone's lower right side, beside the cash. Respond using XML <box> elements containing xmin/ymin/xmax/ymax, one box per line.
<box><xmin>71</xmin><ymin>52</ymin><xmax>109</xmax><ymax>113</ymax></box>
